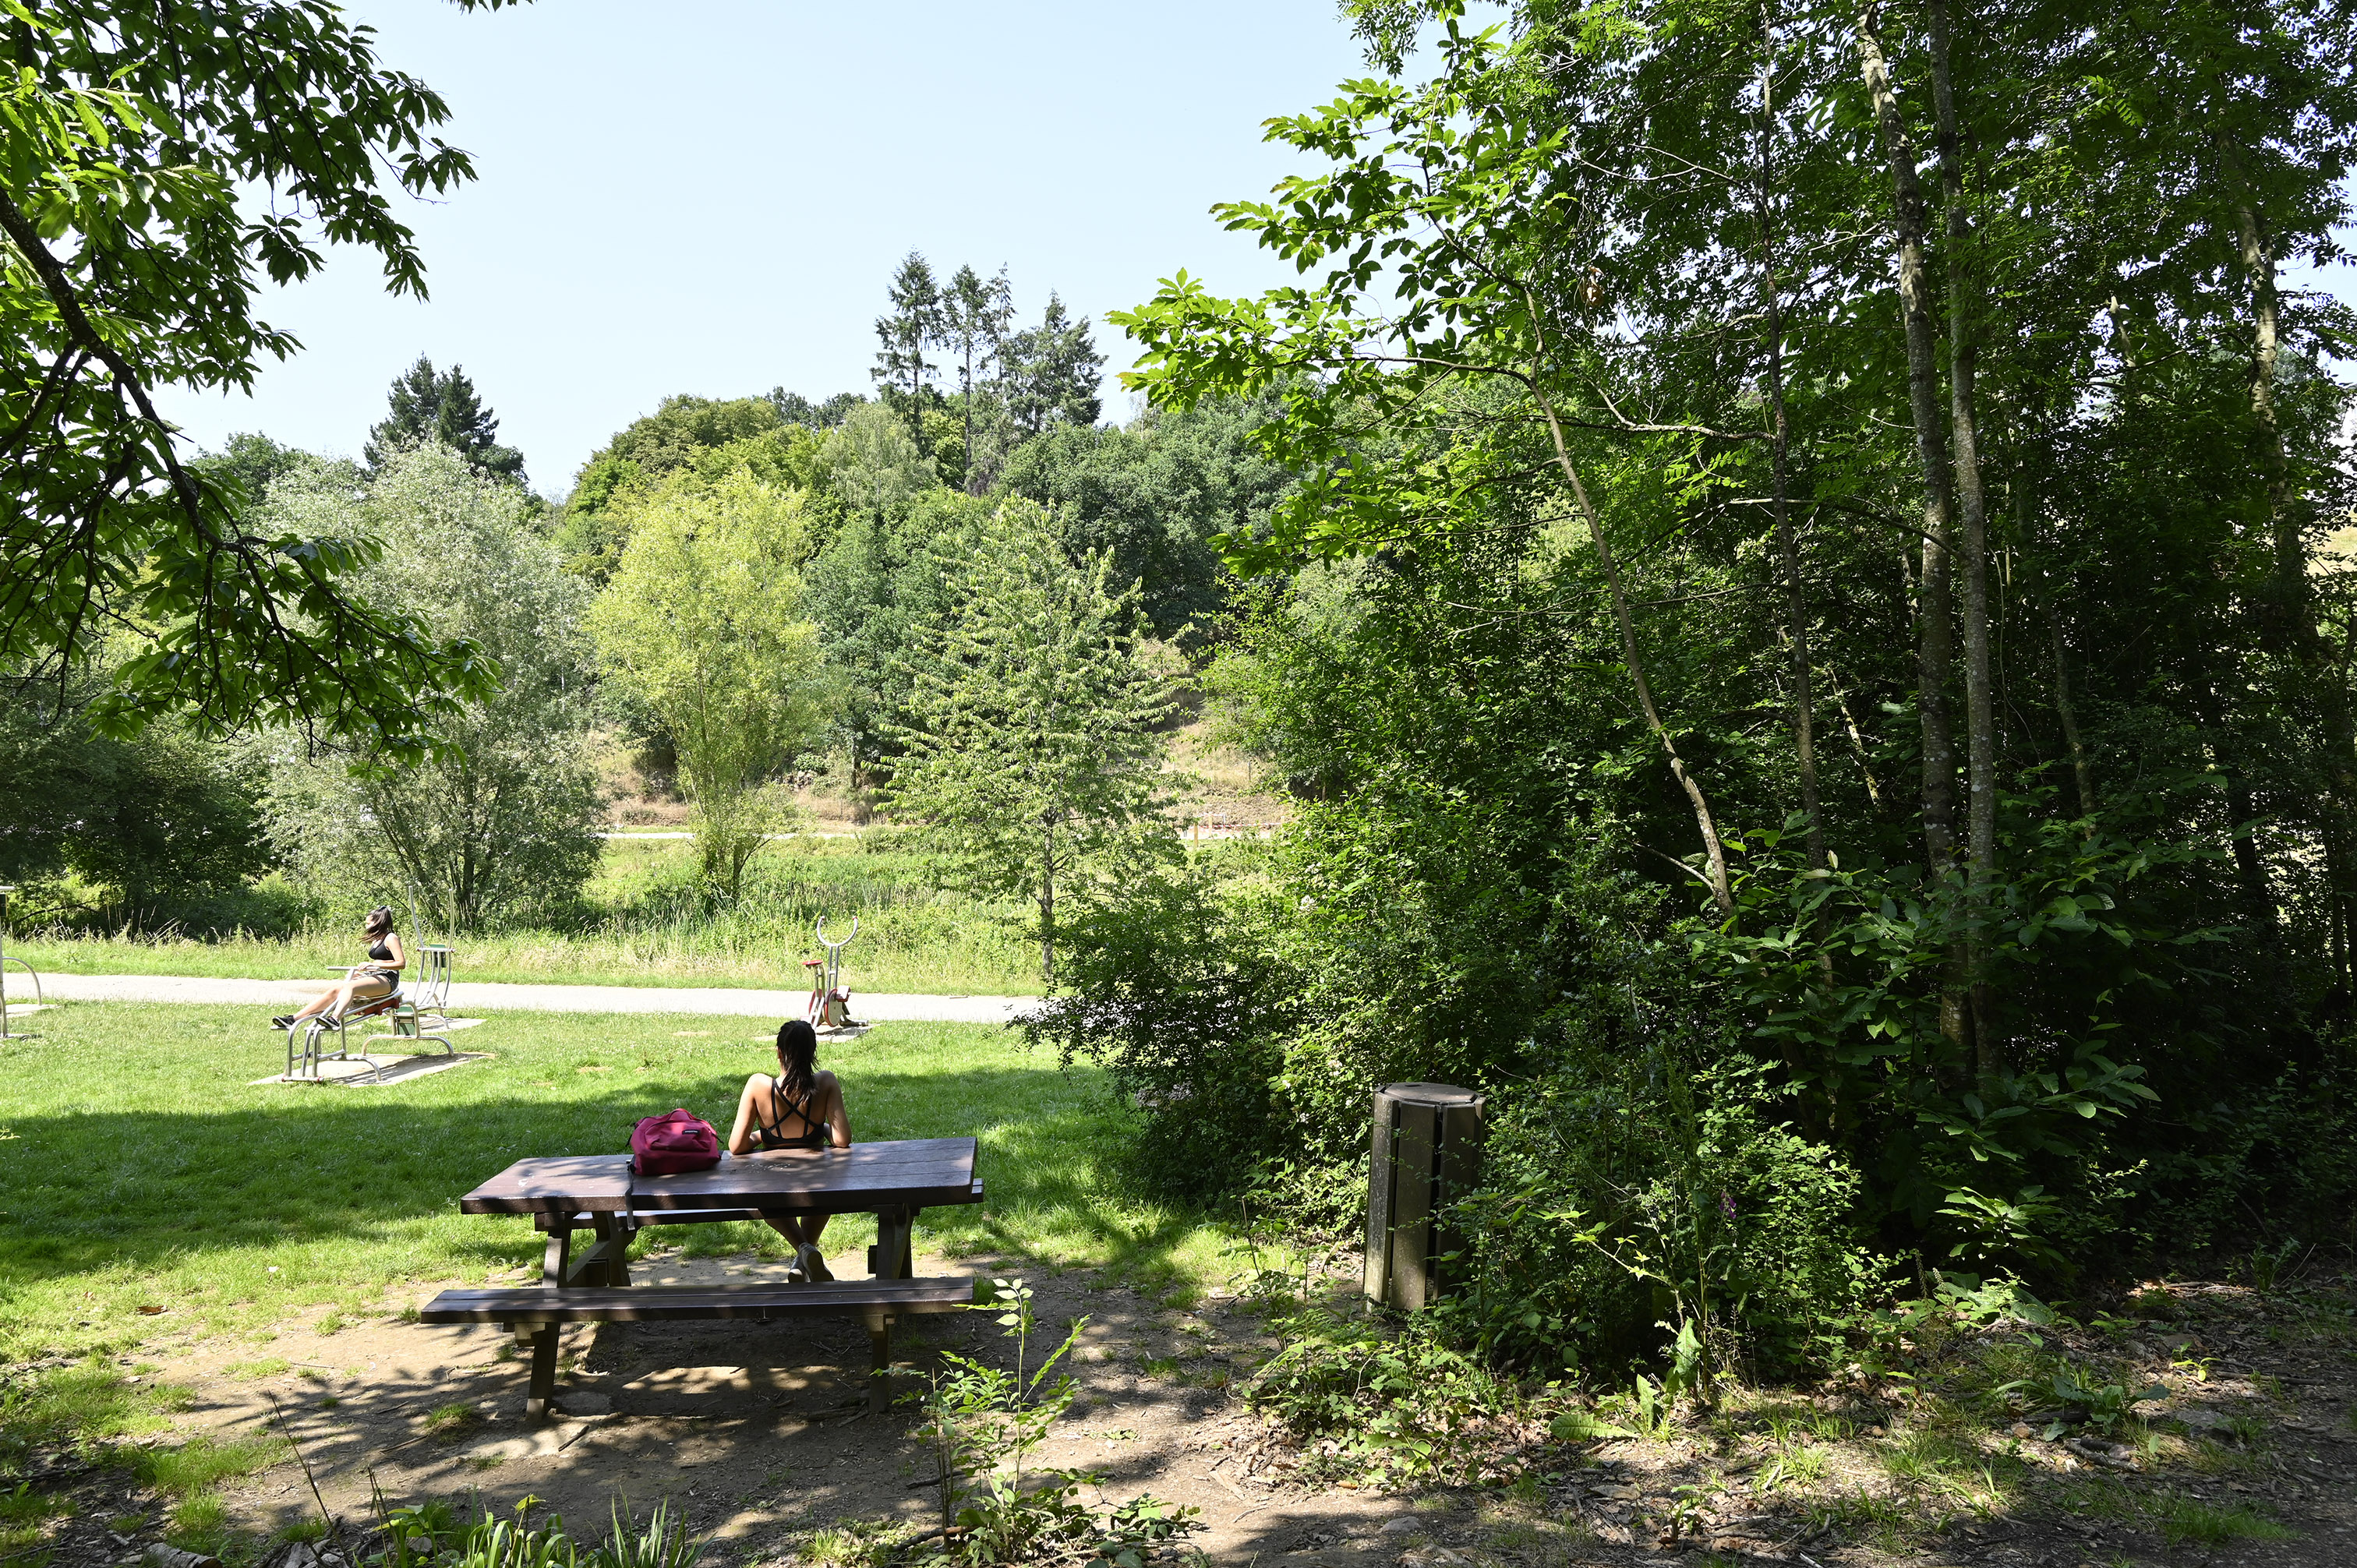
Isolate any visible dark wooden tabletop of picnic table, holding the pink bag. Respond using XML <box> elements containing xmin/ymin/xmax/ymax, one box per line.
<box><xmin>458</xmin><ymin>1139</ymin><xmax>983</xmax><ymax>1214</ymax></box>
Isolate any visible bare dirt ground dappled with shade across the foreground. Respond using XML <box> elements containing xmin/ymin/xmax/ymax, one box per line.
<box><xmin>13</xmin><ymin>1252</ymin><xmax>2357</xmax><ymax>1568</ymax></box>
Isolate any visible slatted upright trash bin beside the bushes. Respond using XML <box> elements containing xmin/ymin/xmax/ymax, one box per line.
<box><xmin>1365</xmin><ymin>1085</ymin><xmax>1485</xmax><ymax>1311</ymax></box>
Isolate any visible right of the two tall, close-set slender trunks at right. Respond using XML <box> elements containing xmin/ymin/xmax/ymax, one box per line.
<box><xmin>1928</xmin><ymin>0</ymin><xmax>2003</xmax><ymax>1082</ymax></box>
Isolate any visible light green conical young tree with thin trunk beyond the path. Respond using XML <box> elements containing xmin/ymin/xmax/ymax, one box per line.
<box><xmin>891</xmin><ymin>500</ymin><xmax>1174</xmax><ymax>981</ymax></box>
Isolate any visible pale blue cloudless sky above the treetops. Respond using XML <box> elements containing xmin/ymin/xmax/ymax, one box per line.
<box><xmin>168</xmin><ymin>0</ymin><xmax>1395</xmax><ymax>495</ymax></box>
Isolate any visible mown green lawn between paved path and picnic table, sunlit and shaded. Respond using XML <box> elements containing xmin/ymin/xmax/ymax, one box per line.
<box><xmin>0</xmin><ymin>1005</ymin><xmax>1240</xmax><ymax>1361</ymax></box>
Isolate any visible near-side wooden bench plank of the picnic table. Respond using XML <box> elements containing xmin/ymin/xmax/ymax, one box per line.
<box><xmin>417</xmin><ymin>1276</ymin><xmax>976</xmax><ymax>1323</ymax></box>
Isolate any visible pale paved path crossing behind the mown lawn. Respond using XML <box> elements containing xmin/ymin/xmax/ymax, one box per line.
<box><xmin>30</xmin><ymin>974</ymin><xmax>1040</xmax><ymax>1023</ymax></box>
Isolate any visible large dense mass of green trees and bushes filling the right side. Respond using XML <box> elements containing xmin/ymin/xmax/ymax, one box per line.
<box><xmin>1091</xmin><ymin>0</ymin><xmax>2357</xmax><ymax>1398</ymax></box>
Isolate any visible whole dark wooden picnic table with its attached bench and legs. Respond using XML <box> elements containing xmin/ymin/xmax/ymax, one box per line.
<box><xmin>419</xmin><ymin>1139</ymin><xmax>983</xmax><ymax>1421</ymax></box>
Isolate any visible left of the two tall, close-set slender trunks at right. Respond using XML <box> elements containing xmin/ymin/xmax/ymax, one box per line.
<box><xmin>1857</xmin><ymin>0</ymin><xmax>1966</xmax><ymax>1051</ymax></box>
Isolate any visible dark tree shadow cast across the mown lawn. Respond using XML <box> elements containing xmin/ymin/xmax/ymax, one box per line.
<box><xmin>0</xmin><ymin>1064</ymin><xmax>1200</xmax><ymax>1301</ymax></box>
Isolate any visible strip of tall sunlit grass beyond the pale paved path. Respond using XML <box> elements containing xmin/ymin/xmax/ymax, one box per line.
<box><xmin>9</xmin><ymin>839</ymin><xmax>1040</xmax><ymax>995</ymax></box>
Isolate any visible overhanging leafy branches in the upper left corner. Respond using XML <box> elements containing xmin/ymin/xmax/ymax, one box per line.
<box><xmin>0</xmin><ymin>0</ymin><xmax>500</xmax><ymax>759</ymax></box>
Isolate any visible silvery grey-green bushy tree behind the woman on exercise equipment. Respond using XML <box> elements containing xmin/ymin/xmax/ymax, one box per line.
<box><xmin>267</xmin><ymin>446</ymin><xmax>603</xmax><ymax>931</ymax></box>
